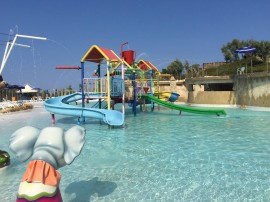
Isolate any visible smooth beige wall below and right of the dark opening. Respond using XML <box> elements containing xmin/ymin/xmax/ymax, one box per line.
<box><xmin>187</xmin><ymin>73</ymin><xmax>270</xmax><ymax>107</ymax></box>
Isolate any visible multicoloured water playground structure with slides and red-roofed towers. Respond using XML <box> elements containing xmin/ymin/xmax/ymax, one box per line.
<box><xmin>44</xmin><ymin>42</ymin><xmax>226</xmax><ymax>126</ymax></box>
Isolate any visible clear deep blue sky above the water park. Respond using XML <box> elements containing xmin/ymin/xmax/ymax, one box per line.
<box><xmin>0</xmin><ymin>0</ymin><xmax>270</xmax><ymax>90</ymax></box>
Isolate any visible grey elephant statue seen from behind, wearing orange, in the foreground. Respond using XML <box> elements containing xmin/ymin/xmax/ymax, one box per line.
<box><xmin>9</xmin><ymin>126</ymin><xmax>85</xmax><ymax>202</ymax></box>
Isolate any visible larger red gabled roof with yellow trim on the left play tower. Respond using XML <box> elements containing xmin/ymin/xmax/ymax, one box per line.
<box><xmin>81</xmin><ymin>45</ymin><xmax>121</xmax><ymax>64</ymax></box>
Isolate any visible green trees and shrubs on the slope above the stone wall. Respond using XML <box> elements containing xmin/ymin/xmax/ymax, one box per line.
<box><xmin>161</xmin><ymin>39</ymin><xmax>270</xmax><ymax>79</ymax></box>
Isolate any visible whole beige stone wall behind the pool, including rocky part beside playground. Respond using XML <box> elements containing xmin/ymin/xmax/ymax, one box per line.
<box><xmin>126</xmin><ymin>73</ymin><xmax>270</xmax><ymax>107</ymax></box>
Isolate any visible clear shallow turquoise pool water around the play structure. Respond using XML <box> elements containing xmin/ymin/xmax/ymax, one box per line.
<box><xmin>0</xmin><ymin>105</ymin><xmax>270</xmax><ymax>202</ymax></box>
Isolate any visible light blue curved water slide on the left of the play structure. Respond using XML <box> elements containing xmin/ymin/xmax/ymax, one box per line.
<box><xmin>44</xmin><ymin>93</ymin><xmax>124</xmax><ymax>126</ymax></box>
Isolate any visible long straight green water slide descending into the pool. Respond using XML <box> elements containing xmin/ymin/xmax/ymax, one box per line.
<box><xmin>141</xmin><ymin>95</ymin><xmax>226</xmax><ymax>116</ymax></box>
